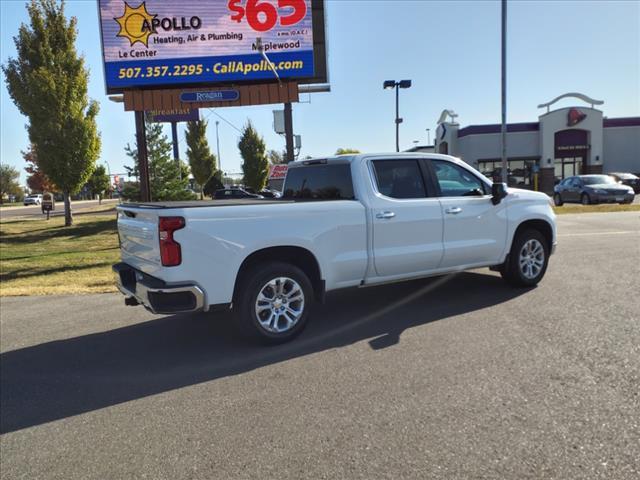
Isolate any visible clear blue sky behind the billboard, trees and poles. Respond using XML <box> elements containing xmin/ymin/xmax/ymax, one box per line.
<box><xmin>0</xmin><ymin>0</ymin><xmax>640</xmax><ymax>180</ymax></box>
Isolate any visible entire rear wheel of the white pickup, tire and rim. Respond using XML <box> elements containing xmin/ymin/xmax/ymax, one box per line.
<box><xmin>234</xmin><ymin>262</ymin><xmax>313</xmax><ymax>344</ymax></box>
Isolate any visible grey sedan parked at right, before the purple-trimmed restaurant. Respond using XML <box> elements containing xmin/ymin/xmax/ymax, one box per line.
<box><xmin>553</xmin><ymin>175</ymin><xmax>635</xmax><ymax>206</ymax></box>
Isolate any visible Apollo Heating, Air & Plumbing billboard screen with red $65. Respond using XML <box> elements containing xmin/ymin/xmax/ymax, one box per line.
<box><xmin>98</xmin><ymin>0</ymin><xmax>326</xmax><ymax>94</ymax></box>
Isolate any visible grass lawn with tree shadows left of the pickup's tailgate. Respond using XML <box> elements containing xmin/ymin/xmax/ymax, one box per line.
<box><xmin>0</xmin><ymin>214</ymin><xmax>120</xmax><ymax>296</ymax></box>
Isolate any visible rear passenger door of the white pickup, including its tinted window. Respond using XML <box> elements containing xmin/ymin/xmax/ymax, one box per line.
<box><xmin>369</xmin><ymin>159</ymin><xmax>443</xmax><ymax>277</ymax></box>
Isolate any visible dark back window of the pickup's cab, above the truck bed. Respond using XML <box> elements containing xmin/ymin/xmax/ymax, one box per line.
<box><xmin>282</xmin><ymin>163</ymin><xmax>354</xmax><ymax>200</ymax></box>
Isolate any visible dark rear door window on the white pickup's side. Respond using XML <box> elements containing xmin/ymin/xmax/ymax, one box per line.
<box><xmin>373</xmin><ymin>160</ymin><xmax>427</xmax><ymax>198</ymax></box>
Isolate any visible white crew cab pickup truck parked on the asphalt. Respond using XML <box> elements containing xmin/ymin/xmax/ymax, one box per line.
<box><xmin>113</xmin><ymin>153</ymin><xmax>556</xmax><ymax>343</ymax></box>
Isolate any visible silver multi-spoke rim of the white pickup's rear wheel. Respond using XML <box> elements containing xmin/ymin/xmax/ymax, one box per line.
<box><xmin>255</xmin><ymin>277</ymin><xmax>304</xmax><ymax>333</ymax></box>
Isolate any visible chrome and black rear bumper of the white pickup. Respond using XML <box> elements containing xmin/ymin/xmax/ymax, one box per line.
<box><xmin>112</xmin><ymin>262</ymin><xmax>208</xmax><ymax>313</ymax></box>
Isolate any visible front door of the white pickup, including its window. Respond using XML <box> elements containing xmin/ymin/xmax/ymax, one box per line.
<box><xmin>429</xmin><ymin>160</ymin><xmax>507</xmax><ymax>268</ymax></box>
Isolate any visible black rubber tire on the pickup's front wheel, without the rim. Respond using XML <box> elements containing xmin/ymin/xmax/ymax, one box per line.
<box><xmin>500</xmin><ymin>229</ymin><xmax>549</xmax><ymax>287</ymax></box>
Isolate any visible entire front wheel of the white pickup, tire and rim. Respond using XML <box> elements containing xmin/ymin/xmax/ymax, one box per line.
<box><xmin>501</xmin><ymin>229</ymin><xmax>549</xmax><ymax>287</ymax></box>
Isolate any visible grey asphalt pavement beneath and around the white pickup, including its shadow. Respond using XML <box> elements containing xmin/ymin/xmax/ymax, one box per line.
<box><xmin>0</xmin><ymin>212</ymin><xmax>640</xmax><ymax>480</ymax></box>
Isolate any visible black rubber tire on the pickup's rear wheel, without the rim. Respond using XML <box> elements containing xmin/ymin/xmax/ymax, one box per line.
<box><xmin>233</xmin><ymin>262</ymin><xmax>313</xmax><ymax>345</ymax></box>
